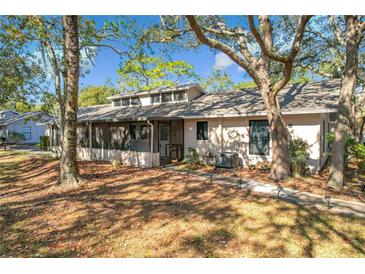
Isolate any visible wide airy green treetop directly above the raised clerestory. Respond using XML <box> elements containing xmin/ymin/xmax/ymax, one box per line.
<box><xmin>118</xmin><ymin>53</ymin><xmax>197</xmax><ymax>91</ymax></box>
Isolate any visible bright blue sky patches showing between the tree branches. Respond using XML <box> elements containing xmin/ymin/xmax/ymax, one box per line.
<box><xmin>80</xmin><ymin>16</ymin><xmax>250</xmax><ymax>88</ymax></box>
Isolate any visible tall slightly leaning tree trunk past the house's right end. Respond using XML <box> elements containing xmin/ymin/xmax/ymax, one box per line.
<box><xmin>327</xmin><ymin>16</ymin><xmax>361</xmax><ymax>190</ymax></box>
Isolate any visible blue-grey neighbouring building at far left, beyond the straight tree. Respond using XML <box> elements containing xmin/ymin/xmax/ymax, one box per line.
<box><xmin>0</xmin><ymin>110</ymin><xmax>52</xmax><ymax>144</ymax></box>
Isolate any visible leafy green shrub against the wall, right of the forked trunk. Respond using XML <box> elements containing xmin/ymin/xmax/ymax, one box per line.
<box><xmin>289</xmin><ymin>138</ymin><xmax>309</xmax><ymax>175</ymax></box>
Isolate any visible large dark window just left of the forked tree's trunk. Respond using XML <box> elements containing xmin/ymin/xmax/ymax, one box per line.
<box><xmin>249</xmin><ymin>120</ymin><xmax>270</xmax><ymax>155</ymax></box>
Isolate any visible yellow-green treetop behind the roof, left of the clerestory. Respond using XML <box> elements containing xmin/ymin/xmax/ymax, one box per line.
<box><xmin>78</xmin><ymin>86</ymin><xmax>118</xmax><ymax>107</ymax></box>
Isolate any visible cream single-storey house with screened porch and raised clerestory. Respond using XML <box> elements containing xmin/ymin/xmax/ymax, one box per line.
<box><xmin>51</xmin><ymin>80</ymin><xmax>340</xmax><ymax>170</ymax></box>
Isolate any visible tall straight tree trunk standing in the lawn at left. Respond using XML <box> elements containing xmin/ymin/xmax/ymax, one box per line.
<box><xmin>60</xmin><ymin>16</ymin><xmax>80</xmax><ymax>186</ymax></box>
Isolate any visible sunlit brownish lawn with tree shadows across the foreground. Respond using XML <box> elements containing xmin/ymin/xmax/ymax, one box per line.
<box><xmin>0</xmin><ymin>151</ymin><xmax>365</xmax><ymax>257</ymax></box>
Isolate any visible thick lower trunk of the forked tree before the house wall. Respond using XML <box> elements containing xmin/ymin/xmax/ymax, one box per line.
<box><xmin>262</xmin><ymin>92</ymin><xmax>291</xmax><ymax>181</ymax></box>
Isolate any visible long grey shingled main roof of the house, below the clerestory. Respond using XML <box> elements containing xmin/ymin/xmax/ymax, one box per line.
<box><xmin>78</xmin><ymin>79</ymin><xmax>341</xmax><ymax>122</ymax></box>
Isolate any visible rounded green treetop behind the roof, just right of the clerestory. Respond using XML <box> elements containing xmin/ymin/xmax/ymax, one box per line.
<box><xmin>200</xmin><ymin>70</ymin><xmax>234</xmax><ymax>93</ymax></box>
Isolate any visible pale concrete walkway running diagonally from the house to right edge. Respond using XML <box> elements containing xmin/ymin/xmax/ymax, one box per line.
<box><xmin>166</xmin><ymin>165</ymin><xmax>365</xmax><ymax>218</ymax></box>
